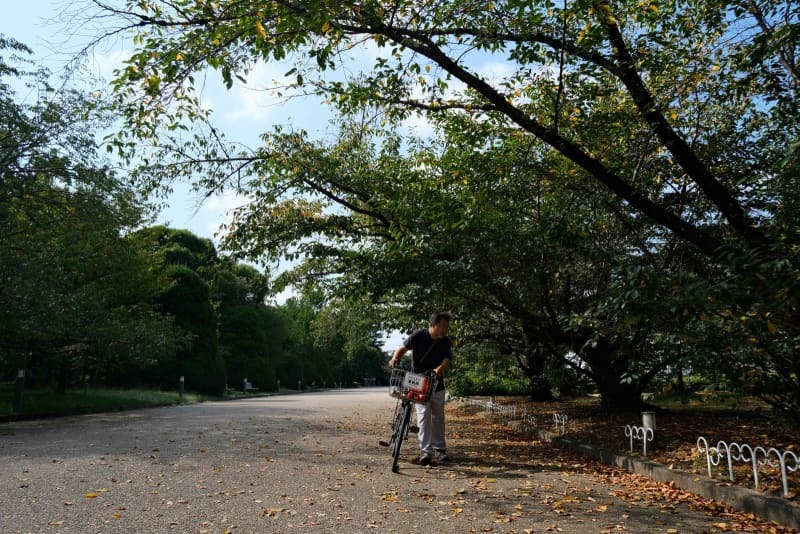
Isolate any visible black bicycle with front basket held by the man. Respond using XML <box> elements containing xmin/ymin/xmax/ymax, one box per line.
<box><xmin>381</xmin><ymin>367</ymin><xmax>437</xmax><ymax>473</ymax></box>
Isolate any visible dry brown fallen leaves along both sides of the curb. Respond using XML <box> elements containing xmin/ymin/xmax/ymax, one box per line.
<box><xmin>448</xmin><ymin>398</ymin><xmax>800</xmax><ymax>534</ymax></box>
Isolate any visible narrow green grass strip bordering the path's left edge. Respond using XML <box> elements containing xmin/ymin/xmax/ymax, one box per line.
<box><xmin>0</xmin><ymin>385</ymin><xmax>201</xmax><ymax>418</ymax></box>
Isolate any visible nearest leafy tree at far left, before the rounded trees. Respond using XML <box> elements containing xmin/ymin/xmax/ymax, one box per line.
<box><xmin>0</xmin><ymin>38</ymin><xmax>178</xmax><ymax>390</ymax></box>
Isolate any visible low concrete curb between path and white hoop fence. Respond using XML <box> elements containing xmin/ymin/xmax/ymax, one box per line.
<box><xmin>506</xmin><ymin>424</ymin><xmax>800</xmax><ymax>529</ymax></box>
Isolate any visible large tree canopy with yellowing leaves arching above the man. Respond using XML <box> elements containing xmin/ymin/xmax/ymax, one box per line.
<box><xmin>87</xmin><ymin>0</ymin><xmax>800</xmax><ymax>417</ymax></box>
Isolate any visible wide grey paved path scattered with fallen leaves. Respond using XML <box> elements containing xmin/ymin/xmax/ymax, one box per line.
<box><xmin>0</xmin><ymin>389</ymin><xmax>724</xmax><ymax>534</ymax></box>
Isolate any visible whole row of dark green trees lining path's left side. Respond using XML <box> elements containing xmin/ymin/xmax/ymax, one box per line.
<box><xmin>0</xmin><ymin>36</ymin><xmax>388</xmax><ymax>394</ymax></box>
